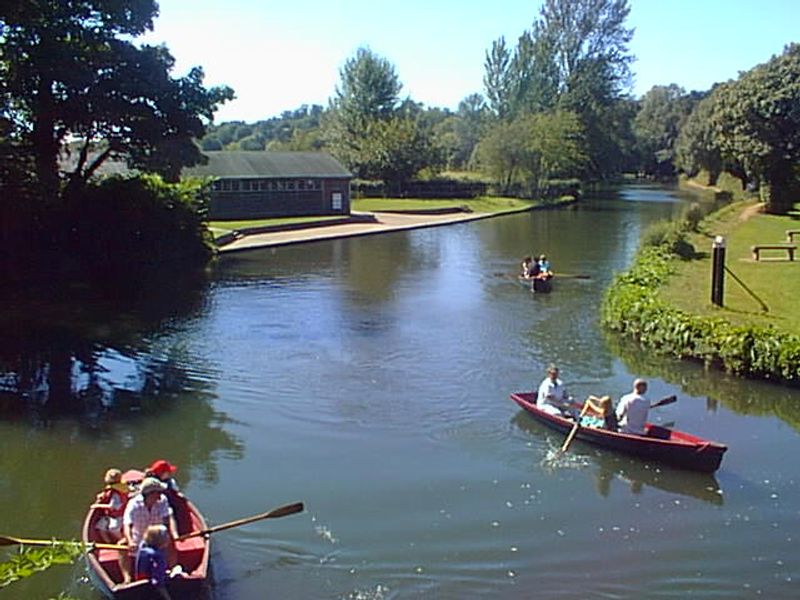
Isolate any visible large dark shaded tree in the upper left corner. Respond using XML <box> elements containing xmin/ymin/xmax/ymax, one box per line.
<box><xmin>0</xmin><ymin>0</ymin><xmax>233</xmax><ymax>200</ymax></box>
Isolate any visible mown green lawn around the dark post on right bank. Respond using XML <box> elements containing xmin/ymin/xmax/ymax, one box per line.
<box><xmin>662</xmin><ymin>201</ymin><xmax>800</xmax><ymax>334</ymax></box>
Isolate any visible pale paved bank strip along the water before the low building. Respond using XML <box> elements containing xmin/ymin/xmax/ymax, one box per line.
<box><xmin>216</xmin><ymin>198</ymin><xmax>577</xmax><ymax>254</ymax></box>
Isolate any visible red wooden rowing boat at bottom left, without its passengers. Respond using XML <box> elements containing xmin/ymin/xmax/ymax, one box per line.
<box><xmin>81</xmin><ymin>471</ymin><xmax>211</xmax><ymax>600</ymax></box>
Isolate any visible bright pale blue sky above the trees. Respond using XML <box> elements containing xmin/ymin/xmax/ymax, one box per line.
<box><xmin>145</xmin><ymin>0</ymin><xmax>800</xmax><ymax>123</ymax></box>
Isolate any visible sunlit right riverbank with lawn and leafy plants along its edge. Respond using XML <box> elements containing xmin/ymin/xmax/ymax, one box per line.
<box><xmin>602</xmin><ymin>178</ymin><xmax>800</xmax><ymax>385</ymax></box>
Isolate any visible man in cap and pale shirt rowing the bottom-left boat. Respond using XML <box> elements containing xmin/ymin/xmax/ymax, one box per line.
<box><xmin>120</xmin><ymin>477</ymin><xmax>178</xmax><ymax>582</ymax></box>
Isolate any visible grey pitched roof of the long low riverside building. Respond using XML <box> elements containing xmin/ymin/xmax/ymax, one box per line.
<box><xmin>188</xmin><ymin>150</ymin><xmax>352</xmax><ymax>178</ymax></box>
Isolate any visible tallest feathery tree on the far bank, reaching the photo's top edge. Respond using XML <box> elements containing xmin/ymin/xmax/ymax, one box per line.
<box><xmin>484</xmin><ymin>0</ymin><xmax>633</xmax><ymax>177</ymax></box>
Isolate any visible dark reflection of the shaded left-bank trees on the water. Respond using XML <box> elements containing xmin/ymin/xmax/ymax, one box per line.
<box><xmin>0</xmin><ymin>268</ymin><xmax>216</xmax><ymax>420</ymax></box>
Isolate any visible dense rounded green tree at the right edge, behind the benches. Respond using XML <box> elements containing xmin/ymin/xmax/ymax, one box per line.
<box><xmin>711</xmin><ymin>44</ymin><xmax>800</xmax><ymax>213</ymax></box>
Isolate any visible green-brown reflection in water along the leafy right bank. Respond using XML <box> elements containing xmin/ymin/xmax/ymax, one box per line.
<box><xmin>606</xmin><ymin>333</ymin><xmax>800</xmax><ymax>430</ymax></box>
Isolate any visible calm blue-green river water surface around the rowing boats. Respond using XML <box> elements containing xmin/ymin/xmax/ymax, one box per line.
<box><xmin>0</xmin><ymin>187</ymin><xmax>800</xmax><ymax>600</ymax></box>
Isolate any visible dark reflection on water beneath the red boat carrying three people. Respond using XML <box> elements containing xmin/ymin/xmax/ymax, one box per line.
<box><xmin>511</xmin><ymin>411</ymin><xmax>723</xmax><ymax>505</ymax></box>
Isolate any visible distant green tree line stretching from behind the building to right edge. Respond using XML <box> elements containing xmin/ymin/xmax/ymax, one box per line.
<box><xmin>200</xmin><ymin>0</ymin><xmax>800</xmax><ymax>212</ymax></box>
